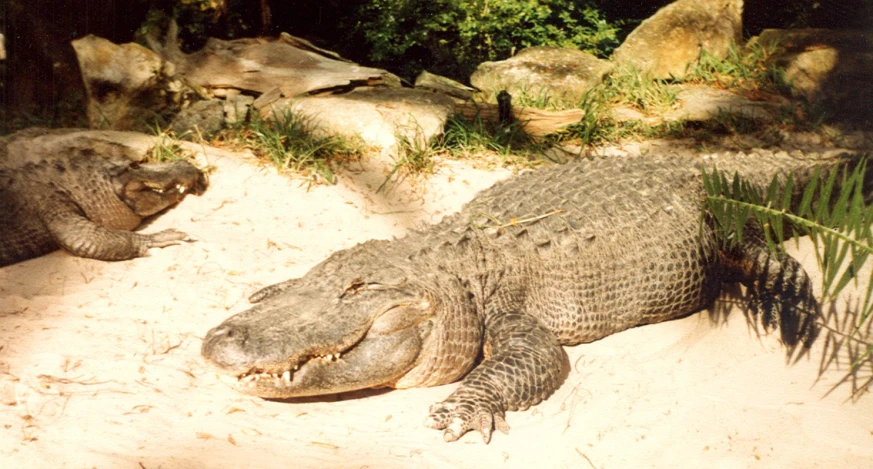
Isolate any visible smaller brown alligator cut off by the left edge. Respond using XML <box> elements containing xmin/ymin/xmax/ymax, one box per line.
<box><xmin>0</xmin><ymin>129</ymin><xmax>206</xmax><ymax>266</ymax></box>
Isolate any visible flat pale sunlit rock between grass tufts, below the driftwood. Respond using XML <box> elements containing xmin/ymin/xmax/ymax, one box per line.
<box><xmin>260</xmin><ymin>87</ymin><xmax>454</xmax><ymax>149</ymax></box>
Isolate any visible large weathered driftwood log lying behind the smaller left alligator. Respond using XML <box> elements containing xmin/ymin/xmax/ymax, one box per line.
<box><xmin>73</xmin><ymin>20</ymin><xmax>400</xmax><ymax>130</ymax></box>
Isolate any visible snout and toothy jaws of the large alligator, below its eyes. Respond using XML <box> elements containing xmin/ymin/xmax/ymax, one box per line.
<box><xmin>202</xmin><ymin>295</ymin><xmax>432</xmax><ymax>398</ymax></box>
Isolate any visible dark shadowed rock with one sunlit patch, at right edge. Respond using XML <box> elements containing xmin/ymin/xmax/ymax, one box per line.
<box><xmin>750</xmin><ymin>29</ymin><xmax>873</xmax><ymax>128</ymax></box>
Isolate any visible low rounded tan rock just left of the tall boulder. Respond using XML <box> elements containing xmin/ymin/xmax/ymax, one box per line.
<box><xmin>470</xmin><ymin>47</ymin><xmax>612</xmax><ymax>104</ymax></box>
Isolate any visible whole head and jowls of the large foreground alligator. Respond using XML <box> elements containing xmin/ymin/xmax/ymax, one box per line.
<box><xmin>202</xmin><ymin>242</ymin><xmax>480</xmax><ymax>398</ymax></box>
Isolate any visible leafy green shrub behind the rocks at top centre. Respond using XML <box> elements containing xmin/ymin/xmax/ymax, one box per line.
<box><xmin>356</xmin><ymin>0</ymin><xmax>618</xmax><ymax>80</ymax></box>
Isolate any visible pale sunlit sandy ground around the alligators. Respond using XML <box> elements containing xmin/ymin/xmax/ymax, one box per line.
<box><xmin>0</xmin><ymin>144</ymin><xmax>873</xmax><ymax>469</ymax></box>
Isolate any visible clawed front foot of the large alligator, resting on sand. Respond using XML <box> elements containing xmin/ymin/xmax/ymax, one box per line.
<box><xmin>424</xmin><ymin>396</ymin><xmax>509</xmax><ymax>444</ymax></box>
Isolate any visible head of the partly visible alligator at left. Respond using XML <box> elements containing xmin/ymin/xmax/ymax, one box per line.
<box><xmin>112</xmin><ymin>160</ymin><xmax>207</xmax><ymax>217</ymax></box>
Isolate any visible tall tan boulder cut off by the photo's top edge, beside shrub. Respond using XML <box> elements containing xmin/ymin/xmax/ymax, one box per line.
<box><xmin>615</xmin><ymin>0</ymin><xmax>743</xmax><ymax>78</ymax></box>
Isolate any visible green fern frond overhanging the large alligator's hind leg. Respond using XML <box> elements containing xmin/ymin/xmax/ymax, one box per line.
<box><xmin>703</xmin><ymin>159</ymin><xmax>873</xmax><ymax>344</ymax></box>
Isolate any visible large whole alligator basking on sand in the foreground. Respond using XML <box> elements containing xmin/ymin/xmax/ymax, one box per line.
<box><xmin>202</xmin><ymin>153</ymin><xmax>857</xmax><ymax>442</ymax></box>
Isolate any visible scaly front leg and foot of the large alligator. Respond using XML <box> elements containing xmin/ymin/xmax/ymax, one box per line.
<box><xmin>425</xmin><ymin>313</ymin><xmax>564</xmax><ymax>443</ymax></box>
